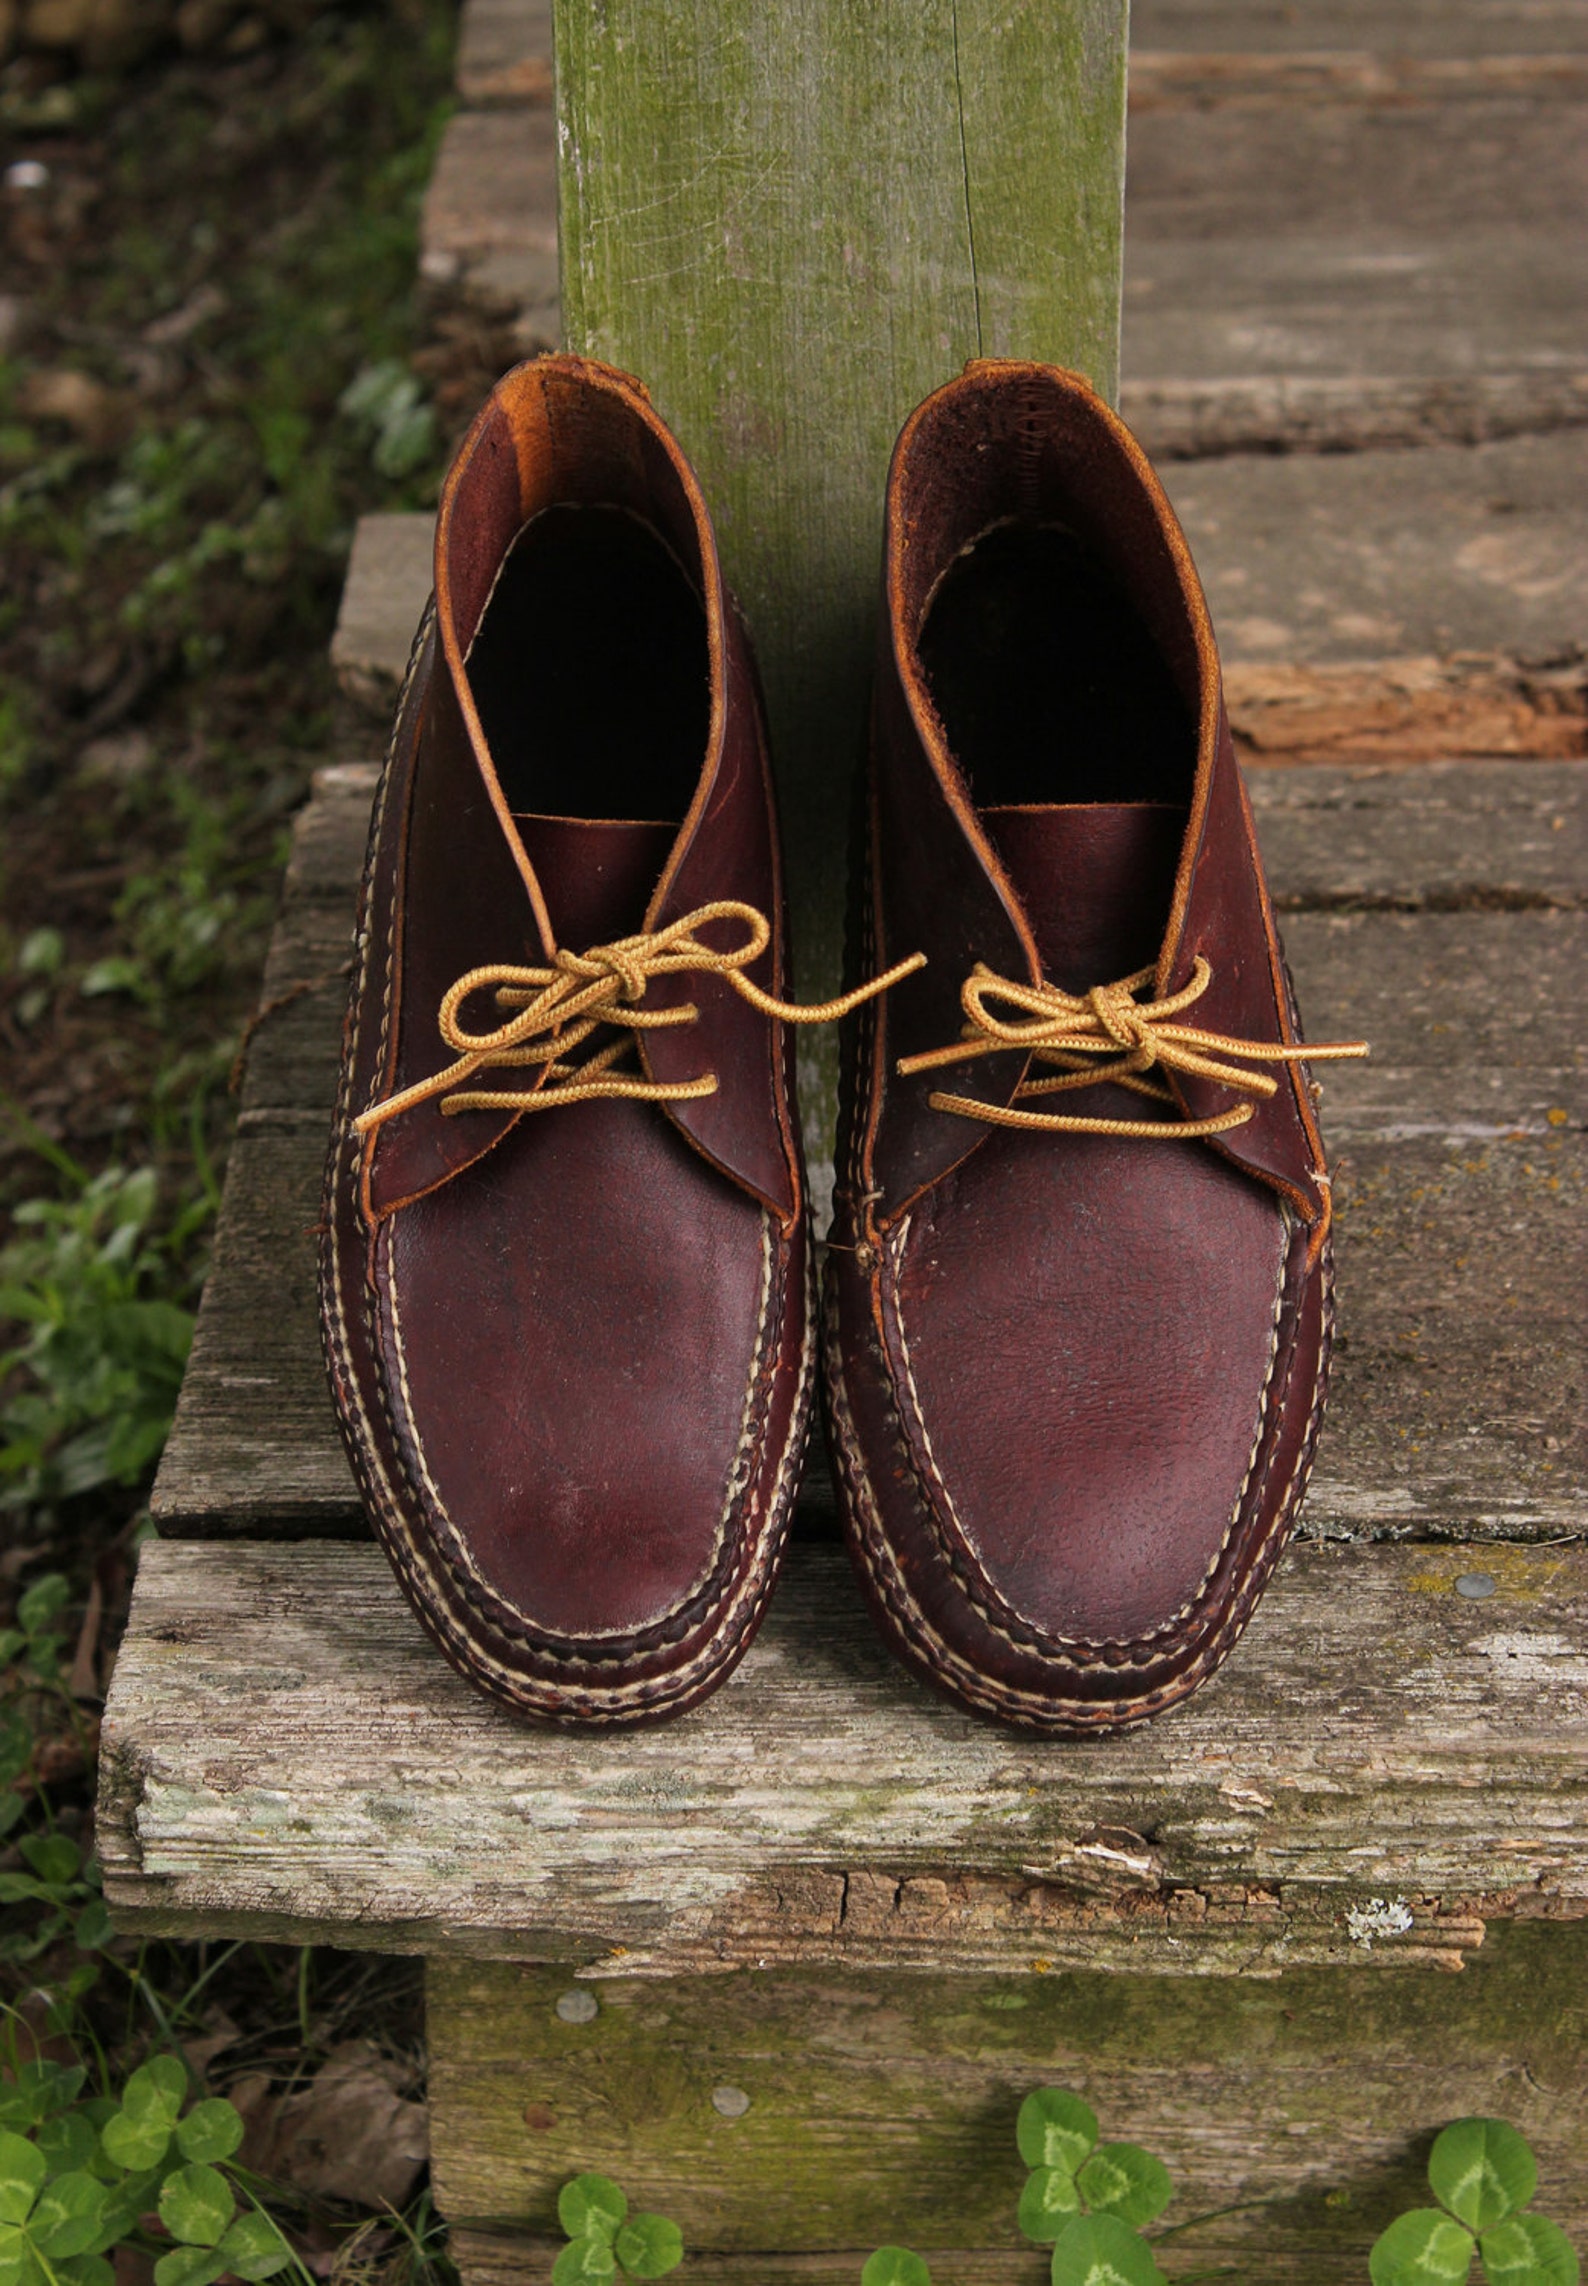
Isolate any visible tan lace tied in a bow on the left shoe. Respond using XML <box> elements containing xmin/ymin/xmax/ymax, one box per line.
<box><xmin>352</xmin><ymin>898</ymin><xmax>925</xmax><ymax>1134</ymax></box>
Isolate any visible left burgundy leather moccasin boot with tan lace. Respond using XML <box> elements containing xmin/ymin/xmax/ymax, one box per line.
<box><xmin>322</xmin><ymin>357</ymin><xmax>904</xmax><ymax>1724</ymax></box>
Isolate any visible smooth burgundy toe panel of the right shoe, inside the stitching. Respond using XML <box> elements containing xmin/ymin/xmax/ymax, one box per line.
<box><xmin>889</xmin><ymin>1134</ymin><xmax>1289</xmax><ymax>1657</ymax></box>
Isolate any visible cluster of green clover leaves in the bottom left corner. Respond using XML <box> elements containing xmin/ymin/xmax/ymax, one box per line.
<box><xmin>0</xmin><ymin>2055</ymin><xmax>295</xmax><ymax>2286</ymax></box>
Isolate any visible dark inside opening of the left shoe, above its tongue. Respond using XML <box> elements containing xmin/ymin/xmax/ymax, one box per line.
<box><xmin>468</xmin><ymin>503</ymin><xmax>711</xmax><ymax>825</ymax></box>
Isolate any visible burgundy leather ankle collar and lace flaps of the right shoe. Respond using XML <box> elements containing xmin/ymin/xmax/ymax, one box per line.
<box><xmin>866</xmin><ymin>361</ymin><xmax>1328</xmax><ymax>1225</ymax></box>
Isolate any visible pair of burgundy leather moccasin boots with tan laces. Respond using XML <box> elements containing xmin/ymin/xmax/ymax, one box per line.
<box><xmin>322</xmin><ymin>357</ymin><xmax>1370</xmax><ymax>1731</ymax></box>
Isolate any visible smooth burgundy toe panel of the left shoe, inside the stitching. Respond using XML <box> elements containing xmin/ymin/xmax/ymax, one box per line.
<box><xmin>379</xmin><ymin>1104</ymin><xmax>784</xmax><ymax>1666</ymax></box>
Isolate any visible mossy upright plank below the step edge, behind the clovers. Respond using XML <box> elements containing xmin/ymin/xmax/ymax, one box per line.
<box><xmin>427</xmin><ymin>1923</ymin><xmax>1588</xmax><ymax>2286</ymax></box>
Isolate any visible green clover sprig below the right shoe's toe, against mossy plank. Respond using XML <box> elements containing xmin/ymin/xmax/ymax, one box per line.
<box><xmin>1014</xmin><ymin>2087</ymin><xmax>1172</xmax><ymax>2286</ymax></box>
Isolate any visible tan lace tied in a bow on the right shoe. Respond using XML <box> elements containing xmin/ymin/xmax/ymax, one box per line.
<box><xmin>898</xmin><ymin>956</ymin><xmax>1369</xmax><ymax>1141</ymax></box>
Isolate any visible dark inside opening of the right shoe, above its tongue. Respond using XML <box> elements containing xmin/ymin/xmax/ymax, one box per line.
<box><xmin>919</xmin><ymin>521</ymin><xmax>1197</xmax><ymax>809</ymax></box>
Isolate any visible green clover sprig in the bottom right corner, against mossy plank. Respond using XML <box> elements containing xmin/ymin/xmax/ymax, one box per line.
<box><xmin>1369</xmin><ymin>2119</ymin><xmax>1579</xmax><ymax>2286</ymax></box>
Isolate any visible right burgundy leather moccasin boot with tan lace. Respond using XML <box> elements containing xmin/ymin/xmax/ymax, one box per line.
<box><xmin>827</xmin><ymin>361</ymin><xmax>1357</xmax><ymax>1733</ymax></box>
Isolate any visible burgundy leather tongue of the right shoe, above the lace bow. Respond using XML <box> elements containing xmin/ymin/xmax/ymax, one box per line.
<box><xmin>980</xmin><ymin>802</ymin><xmax>1186</xmax><ymax>992</ymax></box>
